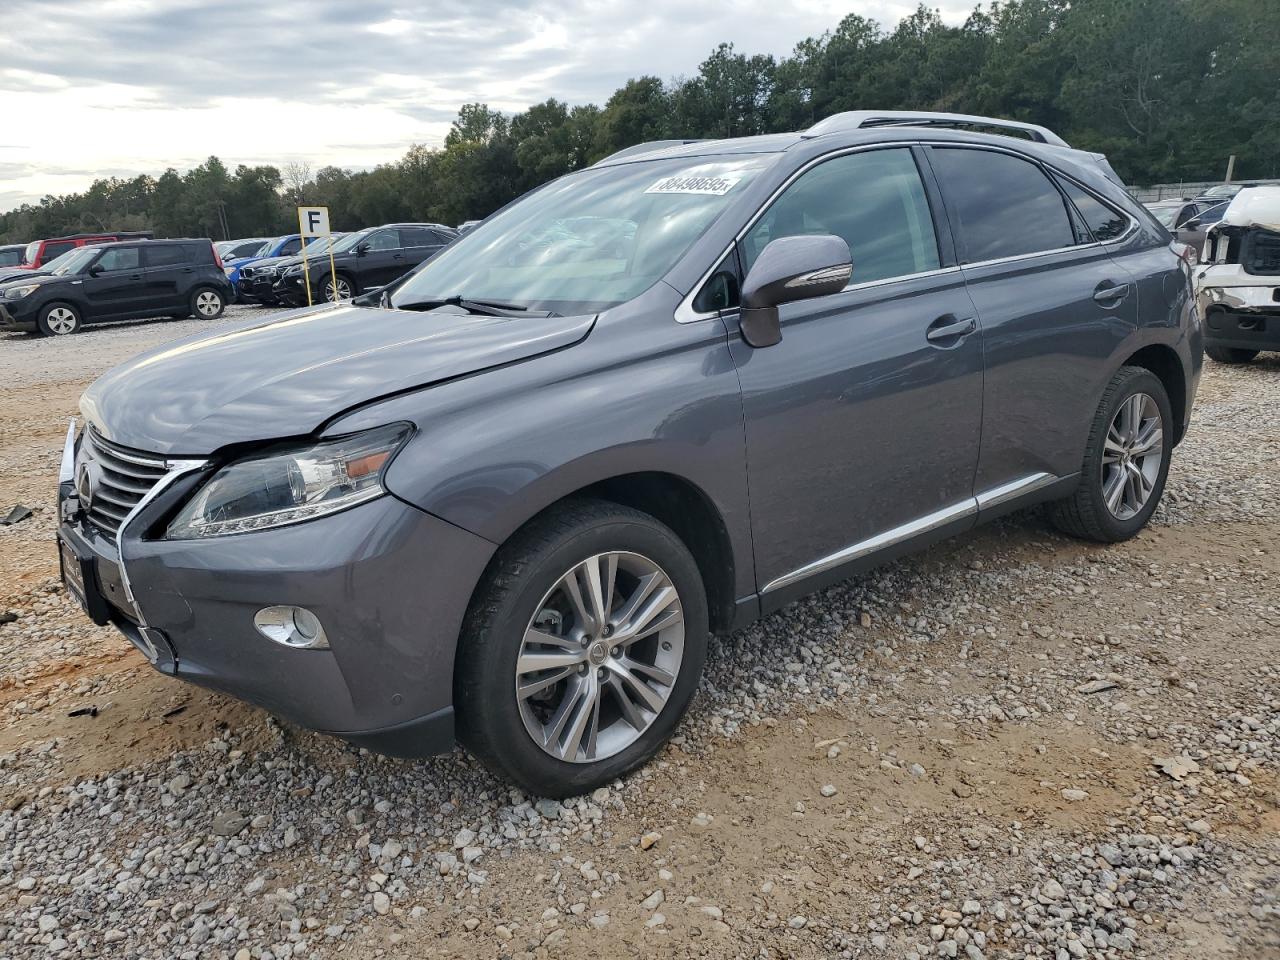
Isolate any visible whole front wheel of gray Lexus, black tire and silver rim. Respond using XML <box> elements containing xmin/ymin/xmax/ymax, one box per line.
<box><xmin>454</xmin><ymin>500</ymin><xmax>708</xmax><ymax>797</ymax></box>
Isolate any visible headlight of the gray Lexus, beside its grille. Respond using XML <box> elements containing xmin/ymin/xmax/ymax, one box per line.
<box><xmin>166</xmin><ymin>424</ymin><xmax>412</xmax><ymax>540</ymax></box>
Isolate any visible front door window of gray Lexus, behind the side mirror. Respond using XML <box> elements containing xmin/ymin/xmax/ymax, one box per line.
<box><xmin>742</xmin><ymin>148</ymin><xmax>938</xmax><ymax>283</ymax></box>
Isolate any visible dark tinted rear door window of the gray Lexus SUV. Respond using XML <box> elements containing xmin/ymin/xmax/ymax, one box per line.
<box><xmin>936</xmin><ymin>147</ymin><xmax>1075</xmax><ymax>261</ymax></box>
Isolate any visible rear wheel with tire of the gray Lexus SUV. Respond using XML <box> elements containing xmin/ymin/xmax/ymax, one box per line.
<box><xmin>1048</xmin><ymin>366</ymin><xmax>1174</xmax><ymax>543</ymax></box>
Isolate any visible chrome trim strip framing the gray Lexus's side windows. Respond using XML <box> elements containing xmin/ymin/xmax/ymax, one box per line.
<box><xmin>676</xmin><ymin>140</ymin><xmax>1138</xmax><ymax>324</ymax></box>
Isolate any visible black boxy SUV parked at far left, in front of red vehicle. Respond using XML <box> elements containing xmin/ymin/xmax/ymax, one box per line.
<box><xmin>0</xmin><ymin>239</ymin><xmax>232</xmax><ymax>337</ymax></box>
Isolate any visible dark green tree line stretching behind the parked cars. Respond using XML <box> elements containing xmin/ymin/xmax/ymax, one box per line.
<box><xmin>0</xmin><ymin>0</ymin><xmax>1280</xmax><ymax>242</ymax></box>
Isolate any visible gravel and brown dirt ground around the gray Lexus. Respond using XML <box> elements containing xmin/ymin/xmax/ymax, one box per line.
<box><xmin>0</xmin><ymin>317</ymin><xmax>1280</xmax><ymax>960</ymax></box>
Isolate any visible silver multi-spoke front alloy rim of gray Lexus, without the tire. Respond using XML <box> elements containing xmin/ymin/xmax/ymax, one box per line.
<box><xmin>516</xmin><ymin>553</ymin><xmax>685</xmax><ymax>763</ymax></box>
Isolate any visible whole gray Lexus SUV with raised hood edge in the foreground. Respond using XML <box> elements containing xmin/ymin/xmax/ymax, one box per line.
<box><xmin>58</xmin><ymin>111</ymin><xmax>1202</xmax><ymax>796</ymax></box>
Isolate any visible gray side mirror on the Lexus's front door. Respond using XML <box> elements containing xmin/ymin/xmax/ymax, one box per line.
<box><xmin>739</xmin><ymin>233</ymin><xmax>854</xmax><ymax>347</ymax></box>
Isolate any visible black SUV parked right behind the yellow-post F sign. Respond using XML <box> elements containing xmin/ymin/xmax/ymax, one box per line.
<box><xmin>273</xmin><ymin>223</ymin><xmax>458</xmax><ymax>306</ymax></box>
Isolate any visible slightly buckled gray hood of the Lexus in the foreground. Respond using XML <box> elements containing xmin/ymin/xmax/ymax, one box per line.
<box><xmin>81</xmin><ymin>306</ymin><xmax>595</xmax><ymax>457</ymax></box>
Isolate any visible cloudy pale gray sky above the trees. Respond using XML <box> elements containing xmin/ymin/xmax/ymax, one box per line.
<box><xmin>0</xmin><ymin>0</ymin><xmax>973</xmax><ymax>210</ymax></box>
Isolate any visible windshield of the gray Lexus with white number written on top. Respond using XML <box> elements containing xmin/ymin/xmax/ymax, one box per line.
<box><xmin>390</xmin><ymin>154</ymin><xmax>777</xmax><ymax>315</ymax></box>
